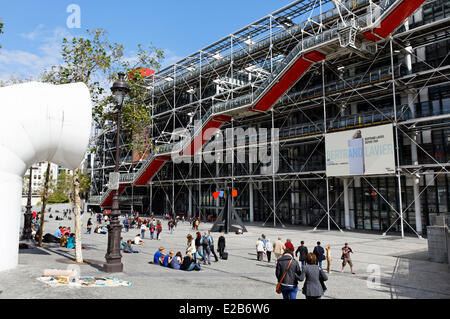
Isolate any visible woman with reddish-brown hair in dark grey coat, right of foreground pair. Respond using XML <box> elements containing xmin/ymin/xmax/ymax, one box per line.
<box><xmin>300</xmin><ymin>253</ymin><xmax>328</xmax><ymax>299</ymax></box>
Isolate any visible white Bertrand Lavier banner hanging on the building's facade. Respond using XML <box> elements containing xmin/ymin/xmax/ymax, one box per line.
<box><xmin>325</xmin><ymin>124</ymin><xmax>395</xmax><ymax>176</ymax></box>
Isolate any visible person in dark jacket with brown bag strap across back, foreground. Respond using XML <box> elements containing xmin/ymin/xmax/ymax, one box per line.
<box><xmin>275</xmin><ymin>248</ymin><xmax>302</xmax><ymax>299</ymax></box>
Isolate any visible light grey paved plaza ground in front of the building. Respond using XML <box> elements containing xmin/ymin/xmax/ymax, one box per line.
<box><xmin>0</xmin><ymin>208</ymin><xmax>450</xmax><ymax>299</ymax></box>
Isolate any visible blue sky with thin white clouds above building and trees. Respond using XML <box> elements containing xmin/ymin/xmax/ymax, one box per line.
<box><xmin>0</xmin><ymin>0</ymin><xmax>291</xmax><ymax>79</ymax></box>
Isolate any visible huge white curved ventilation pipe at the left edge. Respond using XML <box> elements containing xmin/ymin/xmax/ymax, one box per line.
<box><xmin>0</xmin><ymin>82</ymin><xmax>92</xmax><ymax>271</ymax></box>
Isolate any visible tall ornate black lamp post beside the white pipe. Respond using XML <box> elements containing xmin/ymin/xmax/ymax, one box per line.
<box><xmin>103</xmin><ymin>72</ymin><xmax>130</xmax><ymax>273</ymax></box>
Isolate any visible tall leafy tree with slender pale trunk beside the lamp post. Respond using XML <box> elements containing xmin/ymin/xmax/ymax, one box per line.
<box><xmin>42</xmin><ymin>29</ymin><xmax>164</xmax><ymax>263</ymax></box>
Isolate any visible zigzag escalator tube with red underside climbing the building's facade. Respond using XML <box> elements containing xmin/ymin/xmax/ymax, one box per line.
<box><xmin>98</xmin><ymin>0</ymin><xmax>424</xmax><ymax>207</ymax></box>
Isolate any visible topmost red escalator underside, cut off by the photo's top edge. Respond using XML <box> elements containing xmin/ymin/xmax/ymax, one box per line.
<box><xmin>363</xmin><ymin>0</ymin><xmax>425</xmax><ymax>42</ymax></box>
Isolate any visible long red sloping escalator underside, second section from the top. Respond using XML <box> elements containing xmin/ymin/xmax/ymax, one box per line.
<box><xmin>249</xmin><ymin>51</ymin><xmax>326</xmax><ymax>112</ymax></box>
